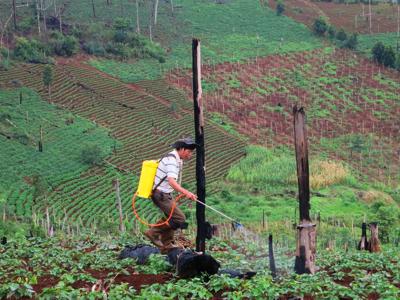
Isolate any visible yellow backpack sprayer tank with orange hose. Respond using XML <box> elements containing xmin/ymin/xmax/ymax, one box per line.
<box><xmin>132</xmin><ymin>153</ymin><xmax>184</xmax><ymax>227</ymax></box>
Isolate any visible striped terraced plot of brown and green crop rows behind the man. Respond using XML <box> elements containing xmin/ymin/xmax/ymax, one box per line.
<box><xmin>0</xmin><ymin>65</ymin><xmax>245</xmax><ymax>222</ymax></box>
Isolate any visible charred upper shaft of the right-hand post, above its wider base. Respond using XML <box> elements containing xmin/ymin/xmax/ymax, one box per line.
<box><xmin>293</xmin><ymin>106</ymin><xmax>311</xmax><ymax>221</ymax></box>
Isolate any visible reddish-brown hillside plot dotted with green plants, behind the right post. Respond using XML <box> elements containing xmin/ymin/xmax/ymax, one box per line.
<box><xmin>168</xmin><ymin>48</ymin><xmax>400</xmax><ymax>183</ymax></box>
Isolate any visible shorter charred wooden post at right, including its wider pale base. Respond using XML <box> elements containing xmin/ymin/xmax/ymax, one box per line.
<box><xmin>293</xmin><ymin>106</ymin><xmax>316</xmax><ymax>274</ymax></box>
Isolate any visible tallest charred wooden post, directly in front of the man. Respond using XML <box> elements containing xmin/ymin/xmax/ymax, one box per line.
<box><xmin>192</xmin><ymin>39</ymin><xmax>206</xmax><ymax>252</ymax></box>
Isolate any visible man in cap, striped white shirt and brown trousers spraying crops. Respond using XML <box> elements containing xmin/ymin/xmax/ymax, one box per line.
<box><xmin>144</xmin><ymin>138</ymin><xmax>197</xmax><ymax>253</ymax></box>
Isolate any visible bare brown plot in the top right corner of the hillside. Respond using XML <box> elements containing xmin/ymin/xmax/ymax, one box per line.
<box><xmin>270</xmin><ymin>0</ymin><xmax>397</xmax><ymax>34</ymax></box>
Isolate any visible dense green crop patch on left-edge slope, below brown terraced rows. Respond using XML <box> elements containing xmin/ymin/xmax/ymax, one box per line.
<box><xmin>0</xmin><ymin>88</ymin><xmax>113</xmax><ymax>210</ymax></box>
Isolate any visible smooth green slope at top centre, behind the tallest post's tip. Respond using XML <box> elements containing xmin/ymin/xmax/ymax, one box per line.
<box><xmin>92</xmin><ymin>0</ymin><xmax>320</xmax><ymax>82</ymax></box>
